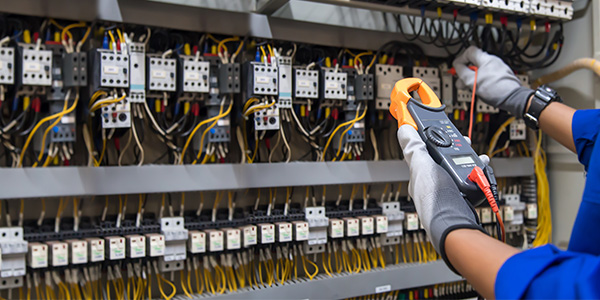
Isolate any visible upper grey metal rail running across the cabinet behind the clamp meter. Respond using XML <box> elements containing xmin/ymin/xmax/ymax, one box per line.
<box><xmin>0</xmin><ymin>158</ymin><xmax>533</xmax><ymax>199</ymax></box>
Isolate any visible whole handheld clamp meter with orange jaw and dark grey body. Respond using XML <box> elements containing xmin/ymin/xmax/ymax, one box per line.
<box><xmin>390</xmin><ymin>78</ymin><xmax>486</xmax><ymax>206</ymax></box>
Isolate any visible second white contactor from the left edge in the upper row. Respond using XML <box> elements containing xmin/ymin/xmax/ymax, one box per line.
<box><xmin>17</xmin><ymin>48</ymin><xmax>52</xmax><ymax>86</ymax></box>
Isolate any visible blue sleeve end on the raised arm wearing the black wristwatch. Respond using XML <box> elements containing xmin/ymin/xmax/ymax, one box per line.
<box><xmin>571</xmin><ymin>109</ymin><xmax>600</xmax><ymax>171</ymax></box>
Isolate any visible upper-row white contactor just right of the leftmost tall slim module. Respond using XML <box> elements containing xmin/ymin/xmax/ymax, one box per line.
<box><xmin>147</xmin><ymin>56</ymin><xmax>177</xmax><ymax>92</ymax></box>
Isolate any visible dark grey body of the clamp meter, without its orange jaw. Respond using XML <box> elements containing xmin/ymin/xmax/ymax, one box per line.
<box><xmin>407</xmin><ymin>98</ymin><xmax>485</xmax><ymax>206</ymax></box>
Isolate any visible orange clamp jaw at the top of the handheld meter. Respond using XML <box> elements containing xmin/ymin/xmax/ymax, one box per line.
<box><xmin>390</xmin><ymin>78</ymin><xmax>442</xmax><ymax>130</ymax></box>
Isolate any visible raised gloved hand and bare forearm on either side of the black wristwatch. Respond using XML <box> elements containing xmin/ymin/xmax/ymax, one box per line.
<box><xmin>453</xmin><ymin>46</ymin><xmax>575</xmax><ymax>152</ymax></box>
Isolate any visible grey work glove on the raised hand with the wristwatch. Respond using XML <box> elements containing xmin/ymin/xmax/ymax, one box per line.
<box><xmin>452</xmin><ymin>46</ymin><xmax>534</xmax><ymax>118</ymax></box>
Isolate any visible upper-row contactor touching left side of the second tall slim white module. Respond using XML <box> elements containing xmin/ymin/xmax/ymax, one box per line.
<box><xmin>246</xmin><ymin>62</ymin><xmax>279</xmax><ymax>96</ymax></box>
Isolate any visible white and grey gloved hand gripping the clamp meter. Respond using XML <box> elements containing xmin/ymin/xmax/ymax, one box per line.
<box><xmin>398</xmin><ymin>125</ymin><xmax>489</xmax><ymax>272</ymax></box>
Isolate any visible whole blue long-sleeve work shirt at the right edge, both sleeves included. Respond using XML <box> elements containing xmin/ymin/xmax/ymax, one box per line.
<box><xmin>495</xmin><ymin>109</ymin><xmax>600</xmax><ymax>299</ymax></box>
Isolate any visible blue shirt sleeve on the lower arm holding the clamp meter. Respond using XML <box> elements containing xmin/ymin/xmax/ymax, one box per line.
<box><xmin>495</xmin><ymin>245</ymin><xmax>600</xmax><ymax>299</ymax></box>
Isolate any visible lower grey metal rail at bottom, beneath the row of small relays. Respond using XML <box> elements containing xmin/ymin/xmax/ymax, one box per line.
<box><xmin>196</xmin><ymin>261</ymin><xmax>462</xmax><ymax>299</ymax></box>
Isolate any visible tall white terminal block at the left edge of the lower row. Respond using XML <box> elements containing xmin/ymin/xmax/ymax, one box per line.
<box><xmin>0</xmin><ymin>227</ymin><xmax>27</xmax><ymax>288</ymax></box>
